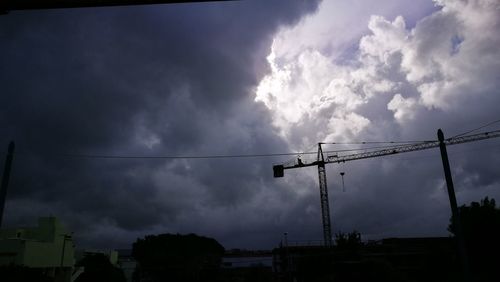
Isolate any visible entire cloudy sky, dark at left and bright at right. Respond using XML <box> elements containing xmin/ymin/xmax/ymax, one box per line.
<box><xmin>0</xmin><ymin>0</ymin><xmax>500</xmax><ymax>249</ymax></box>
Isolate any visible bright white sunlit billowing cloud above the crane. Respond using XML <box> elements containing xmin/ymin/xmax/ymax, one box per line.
<box><xmin>256</xmin><ymin>0</ymin><xmax>500</xmax><ymax>146</ymax></box>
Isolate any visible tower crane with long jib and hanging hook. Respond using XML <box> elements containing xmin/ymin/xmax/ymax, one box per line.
<box><xmin>273</xmin><ymin>130</ymin><xmax>500</xmax><ymax>247</ymax></box>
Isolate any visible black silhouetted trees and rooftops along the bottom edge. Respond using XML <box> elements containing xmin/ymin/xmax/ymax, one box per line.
<box><xmin>0</xmin><ymin>198</ymin><xmax>500</xmax><ymax>282</ymax></box>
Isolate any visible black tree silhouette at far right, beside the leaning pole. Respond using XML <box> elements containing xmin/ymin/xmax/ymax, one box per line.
<box><xmin>448</xmin><ymin>197</ymin><xmax>500</xmax><ymax>281</ymax></box>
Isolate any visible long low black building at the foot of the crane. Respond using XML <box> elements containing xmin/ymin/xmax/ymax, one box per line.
<box><xmin>273</xmin><ymin>237</ymin><xmax>460</xmax><ymax>282</ymax></box>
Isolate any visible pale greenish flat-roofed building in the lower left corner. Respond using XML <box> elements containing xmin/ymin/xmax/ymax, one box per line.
<box><xmin>0</xmin><ymin>217</ymin><xmax>75</xmax><ymax>277</ymax></box>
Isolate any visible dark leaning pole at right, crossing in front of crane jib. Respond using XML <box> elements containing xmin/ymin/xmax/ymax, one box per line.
<box><xmin>437</xmin><ymin>129</ymin><xmax>472</xmax><ymax>281</ymax></box>
